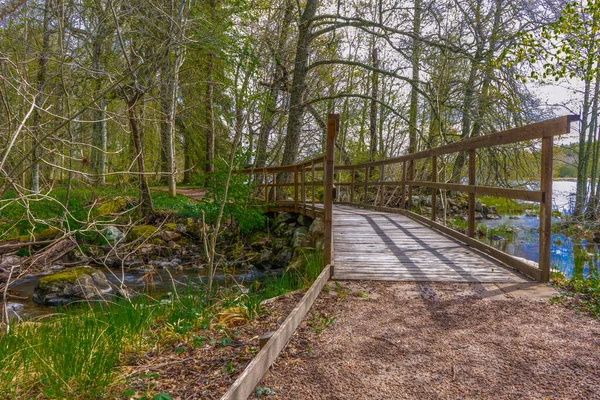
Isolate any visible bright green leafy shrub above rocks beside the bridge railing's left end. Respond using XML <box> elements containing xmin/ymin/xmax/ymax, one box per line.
<box><xmin>178</xmin><ymin>156</ymin><xmax>266</xmax><ymax>234</ymax></box>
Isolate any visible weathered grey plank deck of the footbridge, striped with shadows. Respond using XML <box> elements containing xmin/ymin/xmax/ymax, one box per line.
<box><xmin>333</xmin><ymin>205</ymin><xmax>528</xmax><ymax>282</ymax></box>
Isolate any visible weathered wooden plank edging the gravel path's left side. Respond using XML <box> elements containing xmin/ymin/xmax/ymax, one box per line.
<box><xmin>221</xmin><ymin>265</ymin><xmax>331</xmax><ymax>400</ymax></box>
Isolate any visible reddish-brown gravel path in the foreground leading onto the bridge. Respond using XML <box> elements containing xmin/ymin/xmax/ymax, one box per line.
<box><xmin>257</xmin><ymin>282</ymin><xmax>600</xmax><ymax>399</ymax></box>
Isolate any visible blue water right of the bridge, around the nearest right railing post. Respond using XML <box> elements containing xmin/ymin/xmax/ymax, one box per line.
<box><xmin>480</xmin><ymin>181</ymin><xmax>599</xmax><ymax>278</ymax></box>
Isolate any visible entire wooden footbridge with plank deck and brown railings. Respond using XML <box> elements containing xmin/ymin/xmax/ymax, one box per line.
<box><xmin>244</xmin><ymin>114</ymin><xmax>578</xmax><ymax>282</ymax></box>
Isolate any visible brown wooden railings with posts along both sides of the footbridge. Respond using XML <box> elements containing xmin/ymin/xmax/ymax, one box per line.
<box><xmin>244</xmin><ymin>114</ymin><xmax>579</xmax><ymax>282</ymax></box>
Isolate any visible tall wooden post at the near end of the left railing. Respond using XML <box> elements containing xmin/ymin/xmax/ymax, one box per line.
<box><xmin>323</xmin><ymin>114</ymin><xmax>340</xmax><ymax>265</ymax></box>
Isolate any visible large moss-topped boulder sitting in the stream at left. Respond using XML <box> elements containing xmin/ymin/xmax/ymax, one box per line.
<box><xmin>33</xmin><ymin>265</ymin><xmax>113</xmax><ymax>306</ymax></box>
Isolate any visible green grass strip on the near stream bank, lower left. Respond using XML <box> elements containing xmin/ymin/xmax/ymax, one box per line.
<box><xmin>0</xmin><ymin>252</ymin><xmax>323</xmax><ymax>399</ymax></box>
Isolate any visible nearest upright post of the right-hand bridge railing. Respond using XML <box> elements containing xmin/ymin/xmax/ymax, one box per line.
<box><xmin>539</xmin><ymin>136</ymin><xmax>554</xmax><ymax>282</ymax></box>
